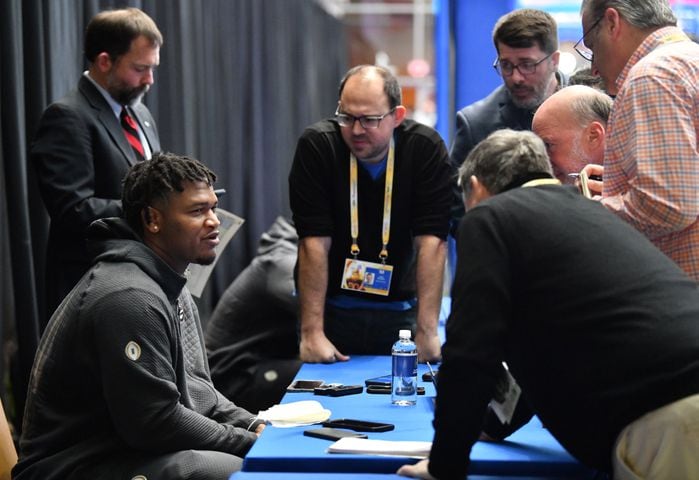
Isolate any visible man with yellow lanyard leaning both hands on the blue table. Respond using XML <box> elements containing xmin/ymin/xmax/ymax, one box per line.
<box><xmin>289</xmin><ymin>65</ymin><xmax>455</xmax><ymax>362</ymax></box>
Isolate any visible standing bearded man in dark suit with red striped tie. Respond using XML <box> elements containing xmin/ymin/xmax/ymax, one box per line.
<box><xmin>30</xmin><ymin>8</ymin><xmax>163</xmax><ymax>319</ymax></box>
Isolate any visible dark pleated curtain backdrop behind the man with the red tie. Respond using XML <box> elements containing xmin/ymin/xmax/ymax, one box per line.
<box><xmin>0</xmin><ymin>0</ymin><xmax>348</xmax><ymax>430</ymax></box>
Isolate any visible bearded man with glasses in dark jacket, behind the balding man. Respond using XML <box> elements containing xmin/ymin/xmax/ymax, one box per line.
<box><xmin>450</xmin><ymin>9</ymin><xmax>565</xmax><ymax>167</ymax></box>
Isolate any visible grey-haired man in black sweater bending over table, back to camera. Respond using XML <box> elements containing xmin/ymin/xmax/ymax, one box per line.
<box><xmin>399</xmin><ymin>130</ymin><xmax>699</xmax><ymax>480</ymax></box>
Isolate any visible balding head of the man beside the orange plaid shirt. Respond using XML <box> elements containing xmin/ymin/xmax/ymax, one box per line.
<box><xmin>532</xmin><ymin>85</ymin><xmax>612</xmax><ymax>182</ymax></box>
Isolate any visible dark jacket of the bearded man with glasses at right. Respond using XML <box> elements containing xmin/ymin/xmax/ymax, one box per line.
<box><xmin>449</xmin><ymin>84</ymin><xmax>533</xmax><ymax>168</ymax></box>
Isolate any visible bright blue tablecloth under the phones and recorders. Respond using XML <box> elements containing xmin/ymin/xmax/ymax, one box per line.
<box><xmin>243</xmin><ymin>356</ymin><xmax>594</xmax><ymax>478</ymax></box>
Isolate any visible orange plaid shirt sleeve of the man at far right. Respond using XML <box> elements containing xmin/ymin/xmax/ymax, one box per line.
<box><xmin>602</xmin><ymin>47</ymin><xmax>699</xmax><ymax>240</ymax></box>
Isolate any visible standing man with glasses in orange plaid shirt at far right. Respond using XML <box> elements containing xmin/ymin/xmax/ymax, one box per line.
<box><xmin>577</xmin><ymin>0</ymin><xmax>699</xmax><ymax>281</ymax></box>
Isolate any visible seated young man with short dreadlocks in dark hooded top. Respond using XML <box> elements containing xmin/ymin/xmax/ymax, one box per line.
<box><xmin>12</xmin><ymin>153</ymin><xmax>264</xmax><ymax>480</ymax></box>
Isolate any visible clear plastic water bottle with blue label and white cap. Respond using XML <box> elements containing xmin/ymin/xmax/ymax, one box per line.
<box><xmin>391</xmin><ymin>330</ymin><xmax>417</xmax><ymax>406</ymax></box>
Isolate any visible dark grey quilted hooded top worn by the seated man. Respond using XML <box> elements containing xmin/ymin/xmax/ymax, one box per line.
<box><xmin>13</xmin><ymin>218</ymin><xmax>256</xmax><ymax>480</ymax></box>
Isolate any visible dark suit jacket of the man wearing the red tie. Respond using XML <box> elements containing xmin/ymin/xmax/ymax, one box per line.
<box><xmin>30</xmin><ymin>76</ymin><xmax>160</xmax><ymax>322</ymax></box>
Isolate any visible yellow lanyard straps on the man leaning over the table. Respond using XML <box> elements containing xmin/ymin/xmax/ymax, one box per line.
<box><xmin>350</xmin><ymin>138</ymin><xmax>395</xmax><ymax>264</ymax></box>
